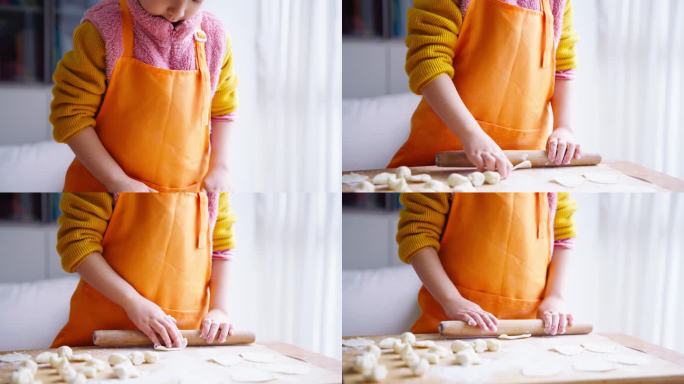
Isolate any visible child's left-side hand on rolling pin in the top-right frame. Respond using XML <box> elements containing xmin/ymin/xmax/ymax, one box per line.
<box><xmin>461</xmin><ymin>130</ymin><xmax>513</xmax><ymax>179</ymax></box>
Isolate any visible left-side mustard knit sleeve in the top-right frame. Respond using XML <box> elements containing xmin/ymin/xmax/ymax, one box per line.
<box><xmin>405</xmin><ymin>0</ymin><xmax>463</xmax><ymax>94</ymax></box>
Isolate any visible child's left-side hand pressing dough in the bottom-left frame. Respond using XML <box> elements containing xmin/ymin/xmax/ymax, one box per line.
<box><xmin>124</xmin><ymin>296</ymin><xmax>183</xmax><ymax>348</ymax></box>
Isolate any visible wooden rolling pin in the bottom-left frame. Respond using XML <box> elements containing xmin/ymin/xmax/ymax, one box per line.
<box><xmin>93</xmin><ymin>329</ymin><xmax>255</xmax><ymax>347</ymax></box>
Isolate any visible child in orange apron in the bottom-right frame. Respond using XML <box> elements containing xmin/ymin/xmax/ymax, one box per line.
<box><xmin>397</xmin><ymin>193</ymin><xmax>576</xmax><ymax>335</ymax></box>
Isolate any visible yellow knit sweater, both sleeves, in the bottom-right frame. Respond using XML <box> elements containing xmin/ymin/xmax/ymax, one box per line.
<box><xmin>397</xmin><ymin>193</ymin><xmax>577</xmax><ymax>263</ymax></box>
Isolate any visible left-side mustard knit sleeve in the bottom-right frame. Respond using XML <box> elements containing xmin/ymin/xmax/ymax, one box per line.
<box><xmin>396</xmin><ymin>193</ymin><xmax>450</xmax><ymax>263</ymax></box>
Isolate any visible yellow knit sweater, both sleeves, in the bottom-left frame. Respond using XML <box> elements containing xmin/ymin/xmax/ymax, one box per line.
<box><xmin>57</xmin><ymin>193</ymin><xmax>235</xmax><ymax>273</ymax></box>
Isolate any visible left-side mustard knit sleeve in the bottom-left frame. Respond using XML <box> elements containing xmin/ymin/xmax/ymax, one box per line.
<box><xmin>57</xmin><ymin>193</ymin><xmax>114</xmax><ymax>273</ymax></box>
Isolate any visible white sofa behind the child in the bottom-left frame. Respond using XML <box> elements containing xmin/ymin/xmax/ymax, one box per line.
<box><xmin>0</xmin><ymin>277</ymin><xmax>78</xmax><ymax>351</ymax></box>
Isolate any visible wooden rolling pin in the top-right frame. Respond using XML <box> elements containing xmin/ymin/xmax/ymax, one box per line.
<box><xmin>435</xmin><ymin>151</ymin><xmax>601</xmax><ymax>168</ymax></box>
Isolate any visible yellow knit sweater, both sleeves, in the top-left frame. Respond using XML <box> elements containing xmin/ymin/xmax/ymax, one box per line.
<box><xmin>50</xmin><ymin>21</ymin><xmax>237</xmax><ymax>143</ymax></box>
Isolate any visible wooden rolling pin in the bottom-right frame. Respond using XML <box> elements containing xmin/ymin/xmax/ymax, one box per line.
<box><xmin>439</xmin><ymin>319</ymin><xmax>594</xmax><ymax>338</ymax></box>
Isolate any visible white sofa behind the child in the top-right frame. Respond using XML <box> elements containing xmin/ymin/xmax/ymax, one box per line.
<box><xmin>342</xmin><ymin>93</ymin><xmax>420</xmax><ymax>171</ymax></box>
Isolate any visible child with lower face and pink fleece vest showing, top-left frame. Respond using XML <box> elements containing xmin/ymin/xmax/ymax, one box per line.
<box><xmin>50</xmin><ymin>0</ymin><xmax>237</xmax><ymax>192</ymax></box>
